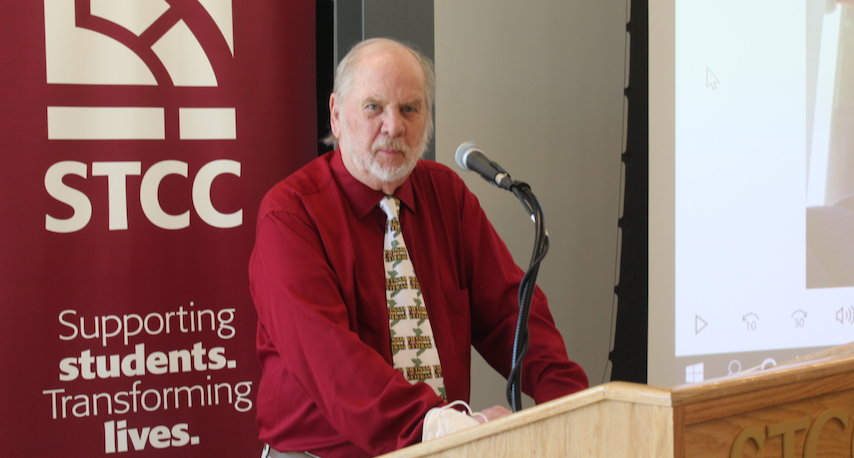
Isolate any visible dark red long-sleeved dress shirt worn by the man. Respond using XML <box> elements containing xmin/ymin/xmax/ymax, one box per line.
<box><xmin>249</xmin><ymin>151</ymin><xmax>587</xmax><ymax>458</ymax></box>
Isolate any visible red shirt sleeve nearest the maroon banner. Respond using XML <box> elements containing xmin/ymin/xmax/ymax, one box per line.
<box><xmin>250</xmin><ymin>206</ymin><xmax>443</xmax><ymax>454</ymax></box>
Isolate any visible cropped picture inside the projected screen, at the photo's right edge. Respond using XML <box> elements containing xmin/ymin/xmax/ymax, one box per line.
<box><xmin>806</xmin><ymin>0</ymin><xmax>854</xmax><ymax>288</ymax></box>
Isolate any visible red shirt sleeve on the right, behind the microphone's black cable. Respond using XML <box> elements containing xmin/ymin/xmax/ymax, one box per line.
<box><xmin>462</xmin><ymin>184</ymin><xmax>588</xmax><ymax>404</ymax></box>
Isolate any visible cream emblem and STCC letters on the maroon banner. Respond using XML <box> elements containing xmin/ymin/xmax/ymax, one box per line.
<box><xmin>44</xmin><ymin>0</ymin><xmax>243</xmax><ymax>233</ymax></box>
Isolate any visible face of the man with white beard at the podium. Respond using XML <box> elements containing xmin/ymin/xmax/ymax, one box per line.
<box><xmin>330</xmin><ymin>43</ymin><xmax>429</xmax><ymax>194</ymax></box>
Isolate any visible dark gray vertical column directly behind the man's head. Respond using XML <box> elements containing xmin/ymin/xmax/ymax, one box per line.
<box><xmin>332</xmin><ymin>0</ymin><xmax>436</xmax><ymax>160</ymax></box>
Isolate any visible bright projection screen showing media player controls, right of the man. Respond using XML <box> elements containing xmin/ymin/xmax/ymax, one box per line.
<box><xmin>668</xmin><ymin>0</ymin><xmax>854</xmax><ymax>386</ymax></box>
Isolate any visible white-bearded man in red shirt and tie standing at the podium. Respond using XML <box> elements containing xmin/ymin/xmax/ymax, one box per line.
<box><xmin>250</xmin><ymin>39</ymin><xmax>587</xmax><ymax>458</ymax></box>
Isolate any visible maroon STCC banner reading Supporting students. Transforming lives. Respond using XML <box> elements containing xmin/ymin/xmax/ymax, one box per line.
<box><xmin>0</xmin><ymin>0</ymin><xmax>317</xmax><ymax>457</ymax></box>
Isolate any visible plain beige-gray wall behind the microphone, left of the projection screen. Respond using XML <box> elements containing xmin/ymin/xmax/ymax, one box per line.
<box><xmin>435</xmin><ymin>0</ymin><xmax>628</xmax><ymax>409</ymax></box>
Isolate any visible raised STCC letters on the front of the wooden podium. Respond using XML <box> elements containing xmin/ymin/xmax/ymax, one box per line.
<box><xmin>729</xmin><ymin>408</ymin><xmax>854</xmax><ymax>458</ymax></box>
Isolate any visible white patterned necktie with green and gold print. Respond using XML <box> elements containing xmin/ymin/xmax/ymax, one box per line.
<box><xmin>380</xmin><ymin>196</ymin><xmax>447</xmax><ymax>401</ymax></box>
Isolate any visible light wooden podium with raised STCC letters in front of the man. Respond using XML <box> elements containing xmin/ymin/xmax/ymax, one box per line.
<box><xmin>383</xmin><ymin>344</ymin><xmax>854</xmax><ymax>458</ymax></box>
